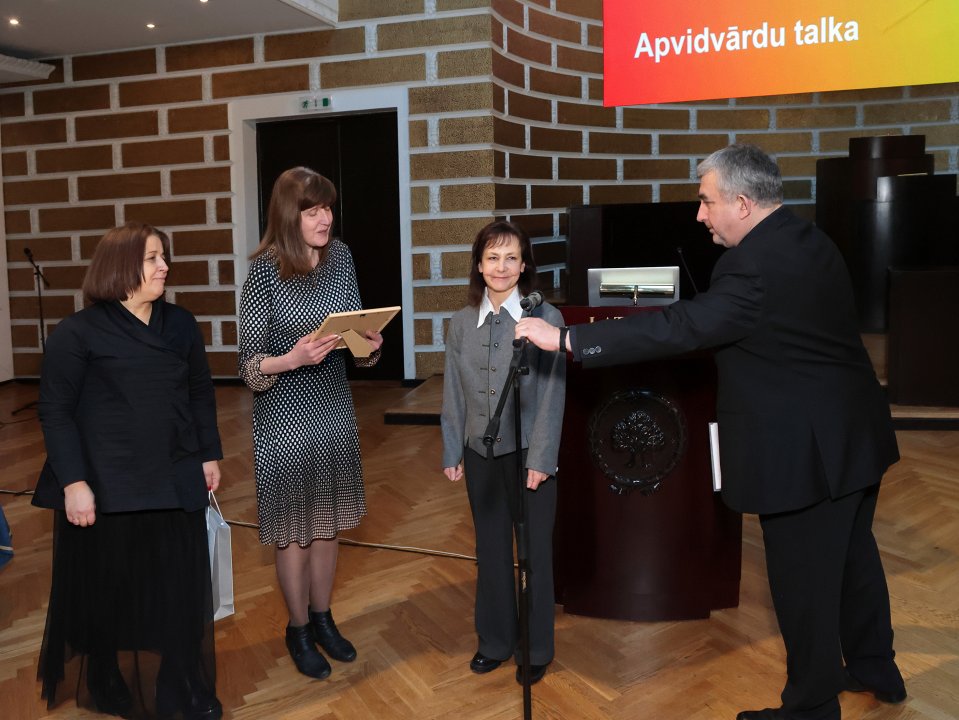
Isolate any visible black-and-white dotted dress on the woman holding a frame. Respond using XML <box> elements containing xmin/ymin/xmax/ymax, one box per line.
<box><xmin>239</xmin><ymin>239</ymin><xmax>366</xmax><ymax>547</ymax></box>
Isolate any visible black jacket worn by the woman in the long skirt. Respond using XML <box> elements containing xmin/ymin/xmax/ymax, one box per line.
<box><xmin>33</xmin><ymin>300</ymin><xmax>223</xmax><ymax>513</ymax></box>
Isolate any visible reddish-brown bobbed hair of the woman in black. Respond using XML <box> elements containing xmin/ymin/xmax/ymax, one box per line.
<box><xmin>83</xmin><ymin>222</ymin><xmax>170</xmax><ymax>305</ymax></box>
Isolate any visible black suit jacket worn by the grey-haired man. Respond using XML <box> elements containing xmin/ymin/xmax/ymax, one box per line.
<box><xmin>570</xmin><ymin>207</ymin><xmax>899</xmax><ymax>513</ymax></box>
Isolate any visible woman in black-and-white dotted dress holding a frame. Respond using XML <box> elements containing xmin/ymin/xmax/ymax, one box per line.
<box><xmin>239</xmin><ymin>167</ymin><xmax>383</xmax><ymax>679</ymax></box>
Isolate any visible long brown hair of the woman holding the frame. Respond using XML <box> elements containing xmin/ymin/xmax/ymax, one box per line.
<box><xmin>250</xmin><ymin>167</ymin><xmax>336</xmax><ymax>280</ymax></box>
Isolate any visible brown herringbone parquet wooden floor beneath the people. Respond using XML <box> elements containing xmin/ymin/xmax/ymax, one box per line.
<box><xmin>0</xmin><ymin>383</ymin><xmax>959</xmax><ymax>720</ymax></box>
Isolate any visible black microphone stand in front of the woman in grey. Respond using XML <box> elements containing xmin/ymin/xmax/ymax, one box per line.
<box><xmin>483</xmin><ymin>338</ymin><xmax>533</xmax><ymax>720</ymax></box>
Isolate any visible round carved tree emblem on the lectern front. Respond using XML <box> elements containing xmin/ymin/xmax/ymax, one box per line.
<box><xmin>589</xmin><ymin>389</ymin><xmax>686</xmax><ymax>495</ymax></box>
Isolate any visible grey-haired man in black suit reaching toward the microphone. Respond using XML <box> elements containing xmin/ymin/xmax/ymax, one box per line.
<box><xmin>516</xmin><ymin>145</ymin><xmax>906</xmax><ymax>720</ymax></box>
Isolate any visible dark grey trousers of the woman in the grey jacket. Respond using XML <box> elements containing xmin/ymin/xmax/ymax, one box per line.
<box><xmin>463</xmin><ymin>448</ymin><xmax>556</xmax><ymax>665</ymax></box>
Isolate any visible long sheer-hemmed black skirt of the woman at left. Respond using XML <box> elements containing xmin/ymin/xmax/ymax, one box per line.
<box><xmin>37</xmin><ymin>510</ymin><xmax>216</xmax><ymax>717</ymax></box>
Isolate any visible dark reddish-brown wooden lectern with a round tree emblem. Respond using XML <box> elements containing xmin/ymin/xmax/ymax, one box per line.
<box><xmin>553</xmin><ymin>307</ymin><xmax>742</xmax><ymax>621</ymax></box>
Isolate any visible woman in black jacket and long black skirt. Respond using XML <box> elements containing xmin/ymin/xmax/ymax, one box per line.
<box><xmin>34</xmin><ymin>223</ymin><xmax>223</xmax><ymax>720</ymax></box>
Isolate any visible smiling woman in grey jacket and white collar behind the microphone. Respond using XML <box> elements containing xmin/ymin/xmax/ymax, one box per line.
<box><xmin>442</xmin><ymin>221</ymin><xmax>566</xmax><ymax>682</ymax></box>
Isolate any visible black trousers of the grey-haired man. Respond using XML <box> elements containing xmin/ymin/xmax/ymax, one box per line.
<box><xmin>759</xmin><ymin>483</ymin><xmax>902</xmax><ymax>720</ymax></box>
